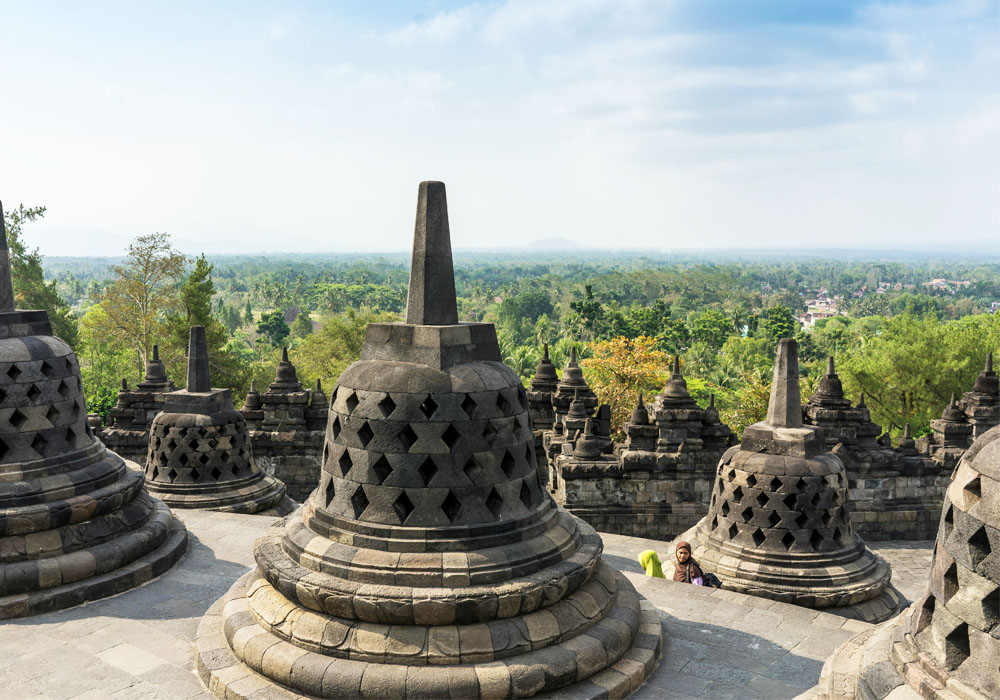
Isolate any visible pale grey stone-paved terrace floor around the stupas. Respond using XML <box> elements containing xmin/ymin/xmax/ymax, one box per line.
<box><xmin>0</xmin><ymin>511</ymin><xmax>932</xmax><ymax>700</ymax></box>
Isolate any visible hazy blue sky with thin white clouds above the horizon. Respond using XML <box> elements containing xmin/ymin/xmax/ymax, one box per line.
<box><xmin>0</xmin><ymin>0</ymin><xmax>1000</xmax><ymax>255</ymax></box>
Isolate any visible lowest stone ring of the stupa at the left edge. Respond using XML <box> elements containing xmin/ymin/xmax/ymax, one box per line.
<box><xmin>0</xmin><ymin>516</ymin><xmax>187</xmax><ymax>620</ymax></box>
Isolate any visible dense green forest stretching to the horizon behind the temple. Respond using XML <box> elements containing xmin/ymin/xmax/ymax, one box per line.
<box><xmin>5</xmin><ymin>207</ymin><xmax>1000</xmax><ymax>434</ymax></box>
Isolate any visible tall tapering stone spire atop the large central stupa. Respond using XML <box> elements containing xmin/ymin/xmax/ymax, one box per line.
<box><xmin>406</xmin><ymin>182</ymin><xmax>458</xmax><ymax>326</ymax></box>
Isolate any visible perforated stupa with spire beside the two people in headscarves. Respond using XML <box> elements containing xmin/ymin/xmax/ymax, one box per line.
<box><xmin>679</xmin><ymin>338</ymin><xmax>902</xmax><ymax>621</ymax></box>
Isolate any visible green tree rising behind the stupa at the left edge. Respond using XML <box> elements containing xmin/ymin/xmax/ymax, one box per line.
<box><xmin>3</xmin><ymin>204</ymin><xmax>78</xmax><ymax>348</ymax></box>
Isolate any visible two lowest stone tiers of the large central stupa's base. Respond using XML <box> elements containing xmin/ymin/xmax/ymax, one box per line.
<box><xmin>195</xmin><ymin>564</ymin><xmax>662</xmax><ymax>700</ymax></box>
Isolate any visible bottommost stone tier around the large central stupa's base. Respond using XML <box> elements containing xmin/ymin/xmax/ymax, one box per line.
<box><xmin>195</xmin><ymin>572</ymin><xmax>662</xmax><ymax>700</ymax></box>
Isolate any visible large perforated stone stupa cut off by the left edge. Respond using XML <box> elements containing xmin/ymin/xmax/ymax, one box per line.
<box><xmin>0</xmin><ymin>200</ymin><xmax>187</xmax><ymax>616</ymax></box>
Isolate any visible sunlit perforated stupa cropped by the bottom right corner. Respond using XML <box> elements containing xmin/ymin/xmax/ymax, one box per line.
<box><xmin>808</xmin><ymin>418</ymin><xmax>1000</xmax><ymax>700</ymax></box>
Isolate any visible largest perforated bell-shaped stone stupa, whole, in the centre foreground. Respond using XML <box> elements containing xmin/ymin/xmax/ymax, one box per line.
<box><xmin>197</xmin><ymin>182</ymin><xmax>661</xmax><ymax>699</ymax></box>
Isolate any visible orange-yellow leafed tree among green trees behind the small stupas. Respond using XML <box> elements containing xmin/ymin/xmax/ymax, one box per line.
<box><xmin>580</xmin><ymin>335</ymin><xmax>671</xmax><ymax>440</ymax></box>
